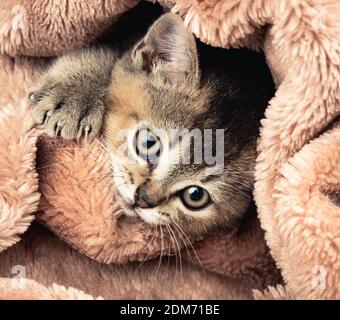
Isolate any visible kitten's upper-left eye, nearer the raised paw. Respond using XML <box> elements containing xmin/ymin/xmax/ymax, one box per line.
<box><xmin>136</xmin><ymin>128</ymin><xmax>161</xmax><ymax>162</ymax></box>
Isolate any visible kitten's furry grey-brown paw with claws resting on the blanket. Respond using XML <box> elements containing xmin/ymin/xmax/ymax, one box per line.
<box><xmin>28</xmin><ymin>83</ymin><xmax>104</xmax><ymax>139</ymax></box>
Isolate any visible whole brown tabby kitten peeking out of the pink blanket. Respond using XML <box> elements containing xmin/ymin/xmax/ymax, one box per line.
<box><xmin>29</xmin><ymin>14</ymin><xmax>274</xmax><ymax>234</ymax></box>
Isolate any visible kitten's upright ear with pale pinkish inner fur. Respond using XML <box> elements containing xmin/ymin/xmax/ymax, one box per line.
<box><xmin>132</xmin><ymin>13</ymin><xmax>199</xmax><ymax>83</ymax></box>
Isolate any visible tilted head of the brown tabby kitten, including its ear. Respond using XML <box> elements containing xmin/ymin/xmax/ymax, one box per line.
<box><xmin>104</xmin><ymin>14</ymin><xmax>272</xmax><ymax>233</ymax></box>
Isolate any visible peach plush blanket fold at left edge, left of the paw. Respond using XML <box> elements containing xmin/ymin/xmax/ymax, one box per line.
<box><xmin>0</xmin><ymin>57</ymin><xmax>40</xmax><ymax>252</ymax></box>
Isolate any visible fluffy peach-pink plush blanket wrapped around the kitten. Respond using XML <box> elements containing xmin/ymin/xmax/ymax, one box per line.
<box><xmin>0</xmin><ymin>0</ymin><xmax>340</xmax><ymax>299</ymax></box>
